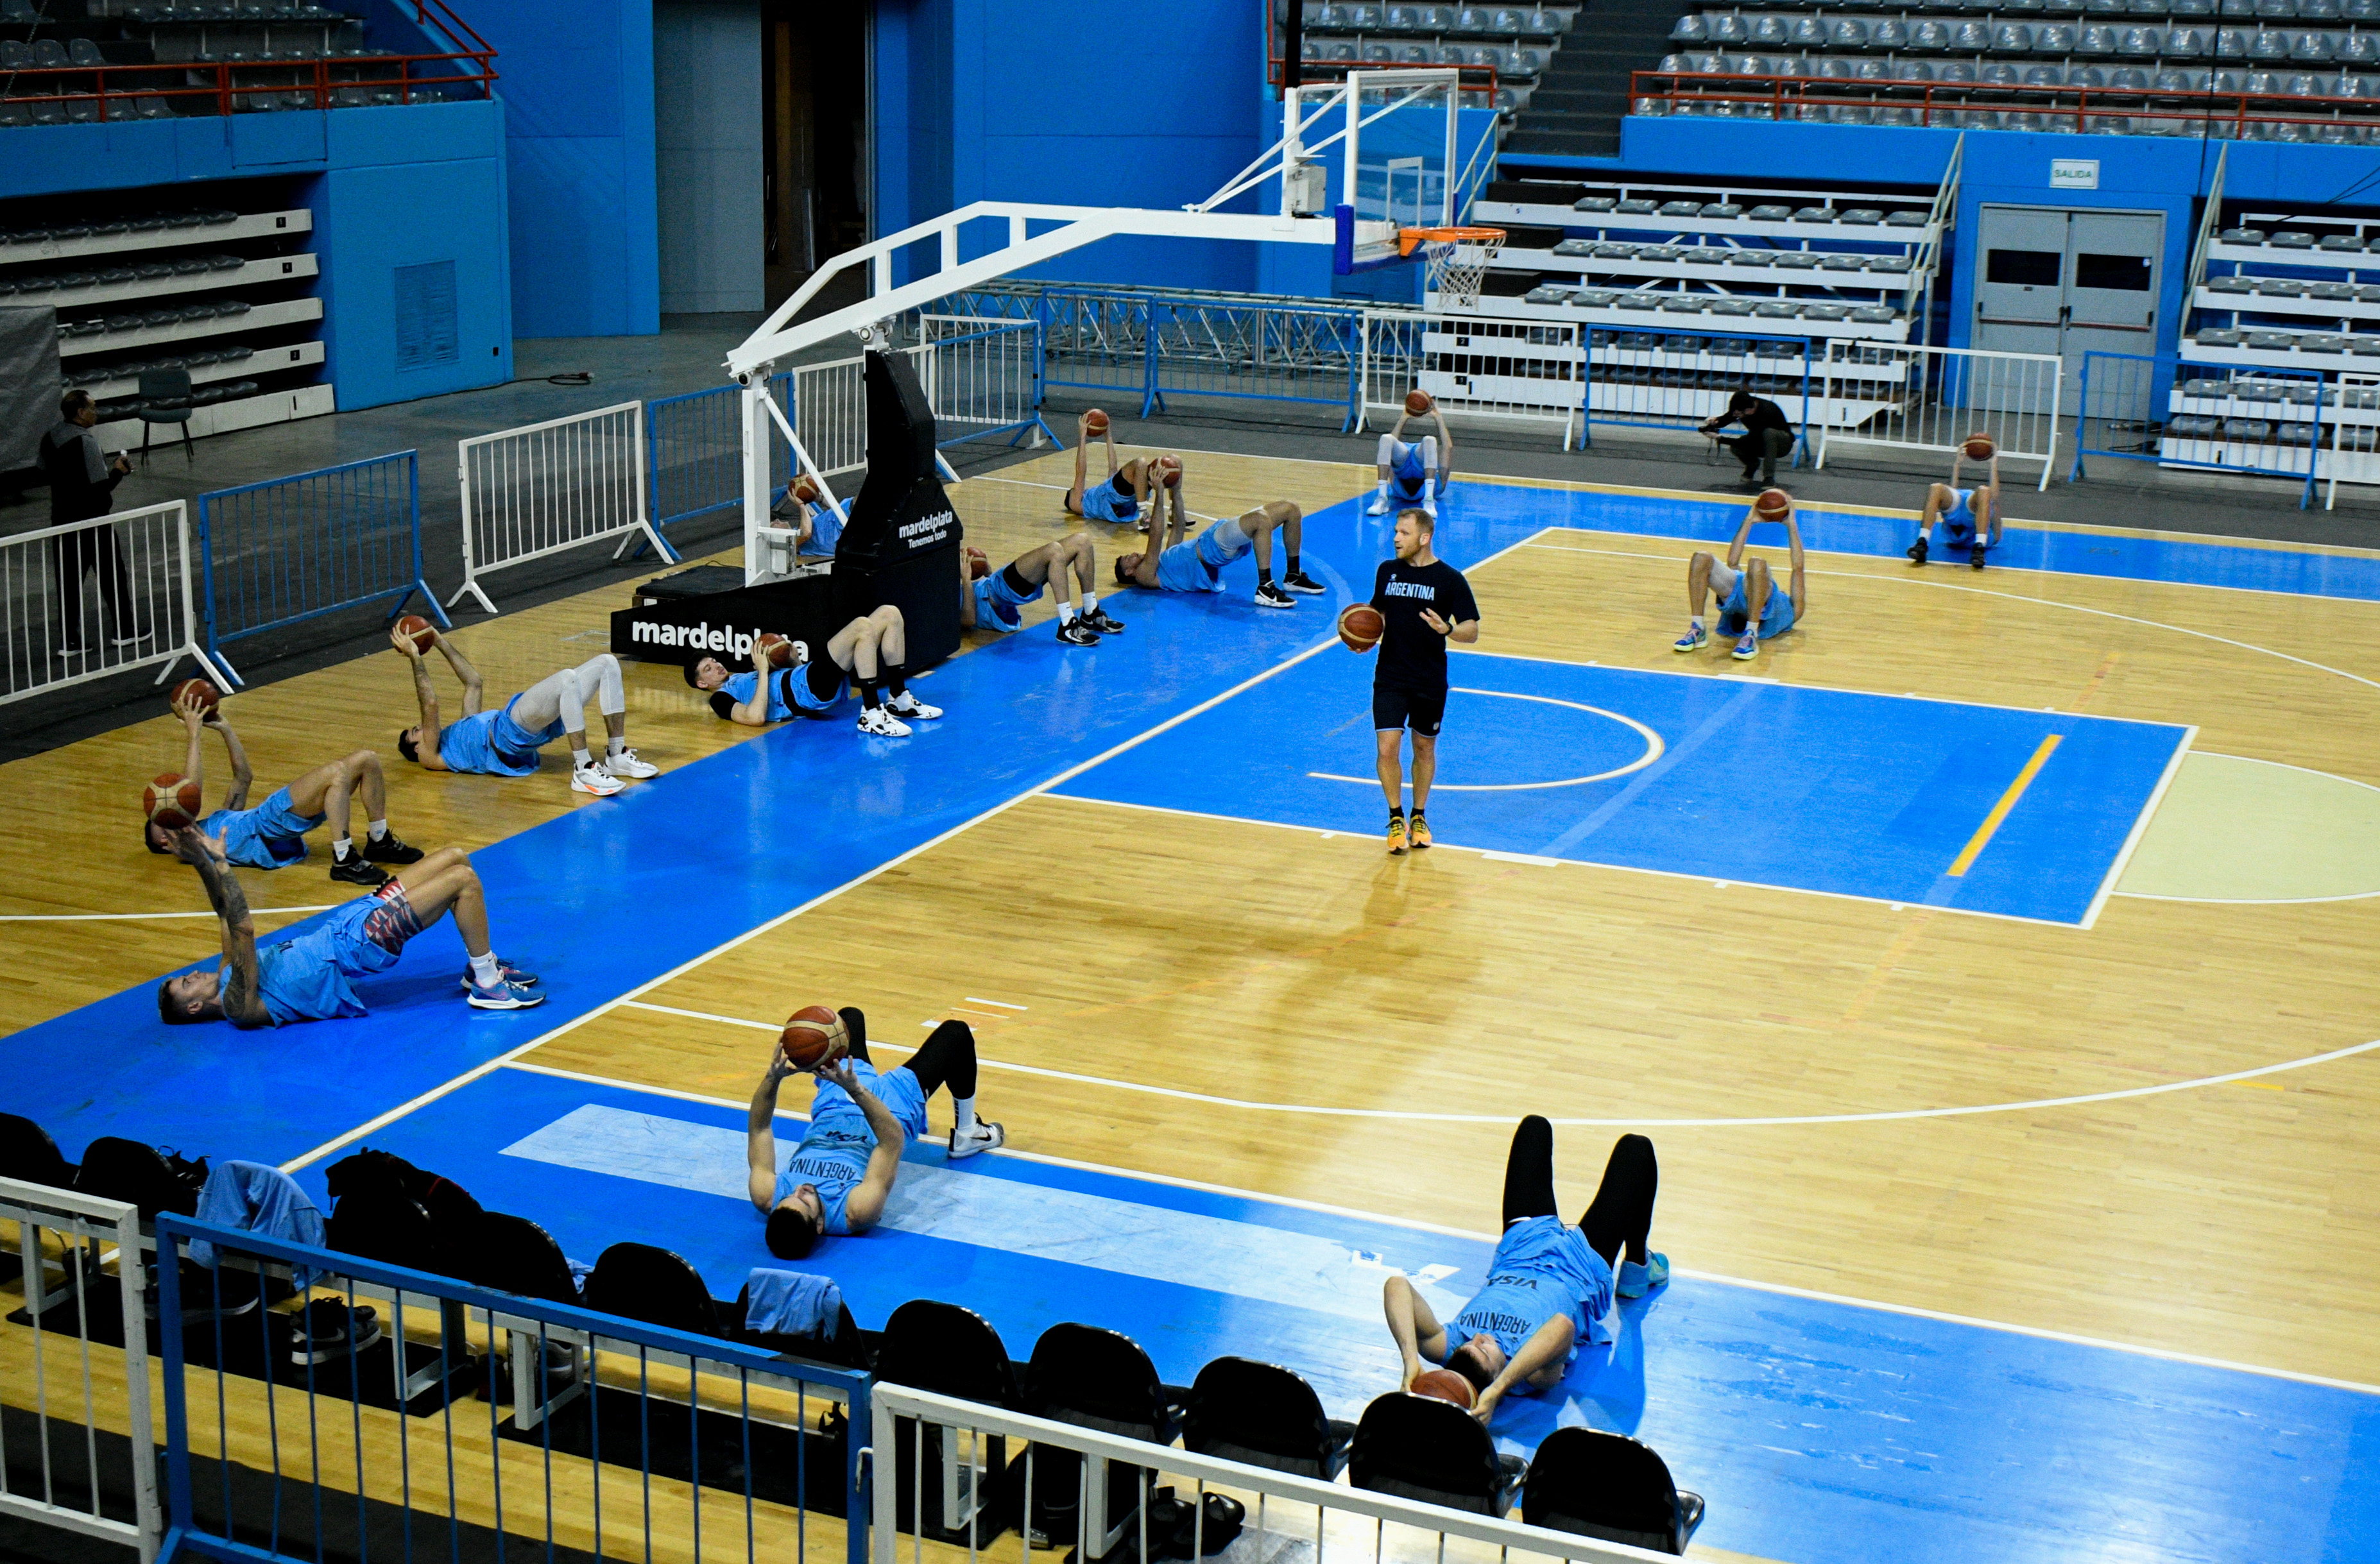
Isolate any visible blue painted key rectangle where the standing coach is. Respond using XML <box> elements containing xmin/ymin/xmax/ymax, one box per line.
<box><xmin>1057</xmin><ymin>652</ymin><xmax>2189</xmax><ymax>924</ymax></box>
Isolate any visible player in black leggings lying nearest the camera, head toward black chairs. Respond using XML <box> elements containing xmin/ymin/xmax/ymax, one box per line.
<box><xmin>1380</xmin><ymin>1114</ymin><xmax>1668</xmax><ymax>1424</ymax></box>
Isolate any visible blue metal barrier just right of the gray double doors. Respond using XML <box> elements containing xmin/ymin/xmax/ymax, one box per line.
<box><xmin>2066</xmin><ymin>352</ymin><xmax>2337</xmax><ymax>509</ymax></box>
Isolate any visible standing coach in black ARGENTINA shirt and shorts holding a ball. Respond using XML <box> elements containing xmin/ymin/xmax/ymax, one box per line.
<box><xmin>1371</xmin><ymin>509</ymin><xmax>1480</xmax><ymax>852</ymax></box>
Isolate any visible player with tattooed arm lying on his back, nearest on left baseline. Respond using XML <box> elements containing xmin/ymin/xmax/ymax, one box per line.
<box><xmin>157</xmin><ymin>826</ymin><xmax>545</xmax><ymax>1026</ymax></box>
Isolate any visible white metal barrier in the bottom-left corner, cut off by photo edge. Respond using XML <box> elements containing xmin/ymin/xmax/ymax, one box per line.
<box><xmin>0</xmin><ymin>1176</ymin><xmax>162</xmax><ymax>1564</ymax></box>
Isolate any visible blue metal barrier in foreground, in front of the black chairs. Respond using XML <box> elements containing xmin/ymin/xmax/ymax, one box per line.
<box><xmin>157</xmin><ymin>1216</ymin><xmax>869</xmax><ymax>1564</ymax></box>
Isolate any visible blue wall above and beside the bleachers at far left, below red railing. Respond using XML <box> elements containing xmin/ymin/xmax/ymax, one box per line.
<box><xmin>0</xmin><ymin>100</ymin><xmax>514</xmax><ymax>407</ymax></box>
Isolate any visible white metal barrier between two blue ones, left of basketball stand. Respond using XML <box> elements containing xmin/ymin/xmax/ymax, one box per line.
<box><xmin>447</xmin><ymin>402</ymin><xmax>678</xmax><ymax>614</ymax></box>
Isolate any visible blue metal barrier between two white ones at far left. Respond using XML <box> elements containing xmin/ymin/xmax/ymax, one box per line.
<box><xmin>198</xmin><ymin>450</ymin><xmax>445</xmax><ymax>688</ymax></box>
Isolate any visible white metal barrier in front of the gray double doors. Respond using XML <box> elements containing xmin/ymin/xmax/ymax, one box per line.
<box><xmin>1811</xmin><ymin>338</ymin><xmax>2066</xmax><ymax>488</ymax></box>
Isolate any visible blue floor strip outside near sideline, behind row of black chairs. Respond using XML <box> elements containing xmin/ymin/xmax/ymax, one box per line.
<box><xmin>330</xmin><ymin>1059</ymin><xmax>2380</xmax><ymax>1564</ymax></box>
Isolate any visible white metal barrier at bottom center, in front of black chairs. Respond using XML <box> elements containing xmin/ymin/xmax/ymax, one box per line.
<box><xmin>869</xmin><ymin>1381</ymin><xmax>1671</xmax><ymax>1564</ymax></box>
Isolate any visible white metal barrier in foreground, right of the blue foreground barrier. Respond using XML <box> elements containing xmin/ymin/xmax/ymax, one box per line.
<box><xmin>869</xmin><ymin>1383</ymin><xmax>1671</xmax><ymax>1564</ymax></box>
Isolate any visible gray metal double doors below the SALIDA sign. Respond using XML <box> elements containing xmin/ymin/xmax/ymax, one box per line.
<box><xmin>1973</xmin><ymin>205</ymin><xmax>2166</xmax><ymax>386</ymax></box>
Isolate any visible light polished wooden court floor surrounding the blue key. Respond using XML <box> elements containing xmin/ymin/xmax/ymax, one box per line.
<box><xmin>0</xmin><ymin>438</ymin><xmax>2380</xmax><ymax>1383</ymax></box>
